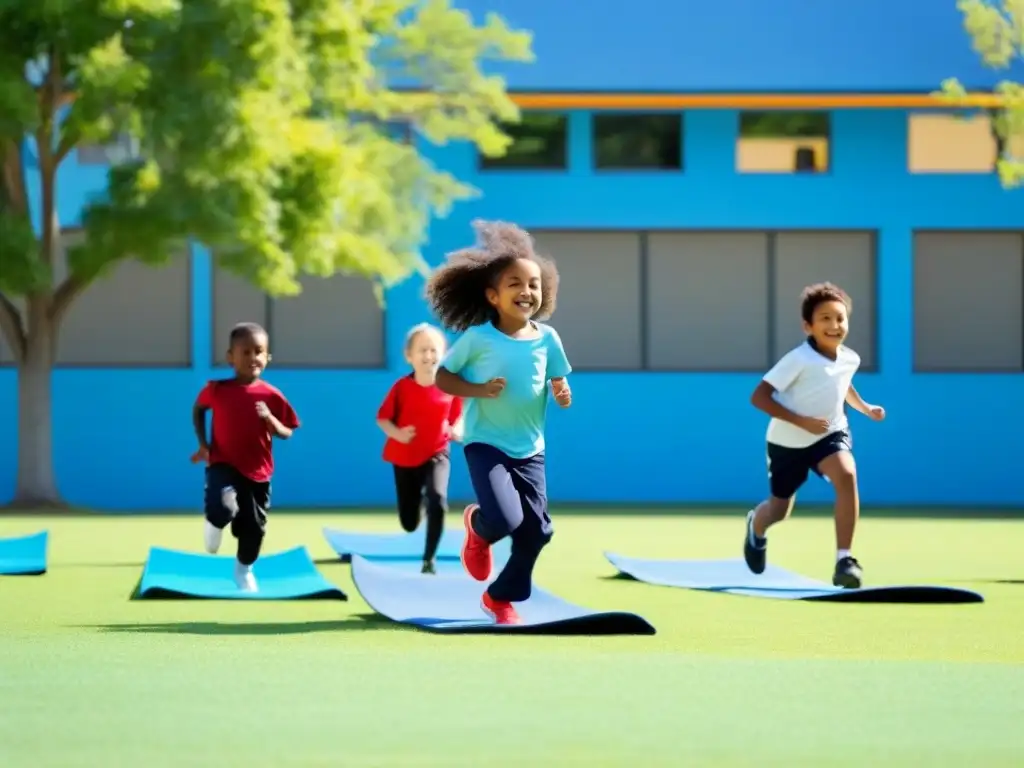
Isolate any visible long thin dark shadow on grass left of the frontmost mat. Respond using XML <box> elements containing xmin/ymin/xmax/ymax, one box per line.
<box><xmin>76</xmin><ymin>613</ymin><xmax>391</xmax><ymax>637</ymax></box>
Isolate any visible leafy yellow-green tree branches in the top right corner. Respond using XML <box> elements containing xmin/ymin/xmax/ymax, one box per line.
<box><xmin>938</xmin><ymin>0</ymin><xmax>1024</xmax><ymax>188</ymax></box>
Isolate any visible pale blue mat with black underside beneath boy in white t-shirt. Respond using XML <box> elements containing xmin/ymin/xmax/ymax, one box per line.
<box><xmin>604</xmin><ymin>552</ymin><xmax>984</xmax><ymax>603</ymax></box>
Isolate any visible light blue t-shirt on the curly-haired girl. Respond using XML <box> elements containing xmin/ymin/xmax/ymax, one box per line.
<box><xmin>441</xmin><ymin>323</ymin><xmax>572</xmax><ymax>459</ymax></box>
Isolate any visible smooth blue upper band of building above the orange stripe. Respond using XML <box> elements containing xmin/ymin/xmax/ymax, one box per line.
<box><xmin>457</xmin><ymin>0</ymin><xmax>1024</xmax><ymax>92</ymax></box>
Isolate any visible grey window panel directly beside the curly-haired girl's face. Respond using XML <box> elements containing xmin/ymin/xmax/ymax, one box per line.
<box><xmin>534</xmin><ymin>231</ymin><xmax>643</xmax><ymax>371</ymax></box>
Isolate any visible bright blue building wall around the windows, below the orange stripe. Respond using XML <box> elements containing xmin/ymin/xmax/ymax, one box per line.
<box><xmin>0</xmin><ymin>111</ymin><xmax>1024</xmax><ymax>509</ymax></box>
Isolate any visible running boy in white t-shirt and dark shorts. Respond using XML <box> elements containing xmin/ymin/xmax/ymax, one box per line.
<box><xmin>743</xmin><ymin>283</ymin><xmax>886</xmax><ymax>589</ymax></box>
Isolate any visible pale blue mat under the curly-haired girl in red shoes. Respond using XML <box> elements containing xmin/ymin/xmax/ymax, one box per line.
<box><xmin>352</xmin><ymin>555</ymin><xmax>654</xmax><ymax>635</ymax></box>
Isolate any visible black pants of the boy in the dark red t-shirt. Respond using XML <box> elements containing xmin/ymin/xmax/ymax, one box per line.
<box><xmin>206</xmin><ymin>464</ymin><xmax>270</xmax><ymax>565</ymax></box>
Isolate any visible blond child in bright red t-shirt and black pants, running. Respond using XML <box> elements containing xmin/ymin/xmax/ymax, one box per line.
<box><xmin>377</xmin><ymin>323</ymin><xmax>462</xmax><ymax>573</ymax></box>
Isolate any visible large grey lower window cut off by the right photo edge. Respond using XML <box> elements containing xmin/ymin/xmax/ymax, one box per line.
<box><xmin>913</xmin><ymin>231</ymin><xmax>1024</xmax><ymax>372</ymax></box>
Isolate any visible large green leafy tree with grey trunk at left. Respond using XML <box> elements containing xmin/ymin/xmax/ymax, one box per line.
<box><xmin>0</xmin><ymin>0</ymin><xmax>532</xmax><ymax>507</ymax></box>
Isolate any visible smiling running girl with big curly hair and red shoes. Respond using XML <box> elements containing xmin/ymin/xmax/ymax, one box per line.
<box><xmin>427</xmin><ymin>221</ymin><xmax>572</xmax><ymax>624</ymax></box>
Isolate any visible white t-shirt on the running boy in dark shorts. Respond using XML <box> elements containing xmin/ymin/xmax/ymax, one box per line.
<box><xmin>764</xmin><ymin>341</ymin><xmax>860</xmax><ymax>447</ymax></box>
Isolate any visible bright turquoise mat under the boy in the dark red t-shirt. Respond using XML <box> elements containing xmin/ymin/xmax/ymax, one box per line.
<box><xmin>133</xmin><ymin>547</ymin><xmax>348</xmax><ymax>600</ymax></box>
